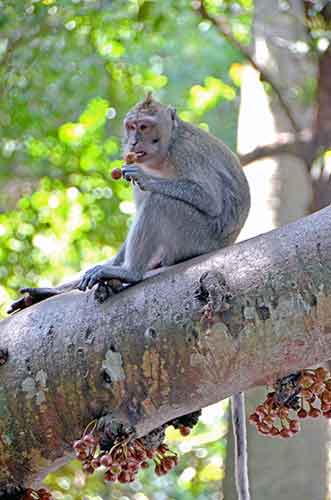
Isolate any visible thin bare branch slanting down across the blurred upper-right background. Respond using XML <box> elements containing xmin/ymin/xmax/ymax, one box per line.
<box><xmin>195</xmin><ymin>0</ymin><xmax>300</xmax><ymax>132</ymax></box>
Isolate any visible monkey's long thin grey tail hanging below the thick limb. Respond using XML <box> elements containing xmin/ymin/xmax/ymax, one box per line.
<box><xmin>231</xmin><ymin>392</ymin><xmax>251</xmax><ymax>500</ymax></box>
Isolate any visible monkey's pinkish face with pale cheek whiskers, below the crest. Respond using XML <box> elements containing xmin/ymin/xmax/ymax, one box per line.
<box><xmin>123</xmin><ymin>110</ymin><xmax>172</xmax><ymax>169</ymax></box>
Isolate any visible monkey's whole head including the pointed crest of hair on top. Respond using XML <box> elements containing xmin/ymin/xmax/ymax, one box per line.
<box><xmin>123</xmin><ymin>94</ymin><xmax>176</xmax><ymax>169</ymax></box>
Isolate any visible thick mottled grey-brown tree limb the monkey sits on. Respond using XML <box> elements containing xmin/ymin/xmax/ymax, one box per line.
<box><xmin>0</xmin><ymin>207</ymin><xmax>331</xmax><ymax>489</ymax></box>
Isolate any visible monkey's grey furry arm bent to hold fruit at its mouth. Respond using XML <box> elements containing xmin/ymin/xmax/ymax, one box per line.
<box><xmin>122</xmin><ymin>165</ymin><xmax>222</xmax><ymax>217</ymax></box>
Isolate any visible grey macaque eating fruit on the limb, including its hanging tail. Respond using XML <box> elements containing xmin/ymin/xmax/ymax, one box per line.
<box><xmin>10</xmin><ymin>95</ymin><xmax>250</xmax><ymax>500</ymax></box>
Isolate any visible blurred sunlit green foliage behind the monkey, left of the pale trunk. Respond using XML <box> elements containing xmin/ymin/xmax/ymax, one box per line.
<box><xmin>0</xmin><ymin>0</ymin><xmax>253</xmax><ymax>500</ymax></box>
